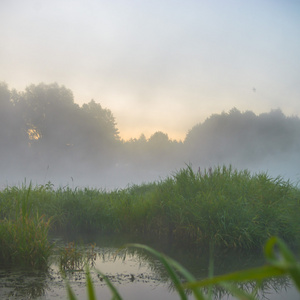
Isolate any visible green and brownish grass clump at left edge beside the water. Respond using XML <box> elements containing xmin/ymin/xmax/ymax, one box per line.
<box><xmin>0</xmin><ymin>184</ymin><xmax>52</xmax><ymax>269</ymax></box>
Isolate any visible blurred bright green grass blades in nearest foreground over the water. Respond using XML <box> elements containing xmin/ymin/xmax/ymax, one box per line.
<box><xmin>67</xmin><ymin>237</ymin><xmax>300</xmax><ymax>300</ymax></box>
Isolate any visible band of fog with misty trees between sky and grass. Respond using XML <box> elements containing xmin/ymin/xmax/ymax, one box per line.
<box><xmin>0</xmin><ymin>83</ymin><xmax>300</xmax><ymax>190</ymax></box>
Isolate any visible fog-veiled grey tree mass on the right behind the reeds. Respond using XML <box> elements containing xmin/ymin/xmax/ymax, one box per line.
<box><xmin>184</xmin><ymin>108</ymin><xmax>300</xmax><ymax>169</ymax></box>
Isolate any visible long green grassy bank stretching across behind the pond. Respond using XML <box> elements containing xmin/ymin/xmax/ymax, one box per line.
<box><xmin>0</xmin><ymin>166</ymin><xmax>300</xmax><ymax>259</ymax></box>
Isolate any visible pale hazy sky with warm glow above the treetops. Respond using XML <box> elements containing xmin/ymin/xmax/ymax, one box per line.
<box><xmin>0</xmin><ymin>0</ymin><xmax>300</xmax><ymax>139</ymax></box>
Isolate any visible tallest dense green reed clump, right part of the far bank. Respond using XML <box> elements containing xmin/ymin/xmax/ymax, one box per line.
<box><xmin>157</xmin><ymin>166</ymin><xmax>300</xmax><ymax>249</ymax></box>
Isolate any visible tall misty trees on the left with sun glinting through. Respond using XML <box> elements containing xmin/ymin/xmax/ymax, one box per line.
<box><xmin>0</xmin><ymin>83</ymin><xmax>120</xmax><ymax>176</ymax></box>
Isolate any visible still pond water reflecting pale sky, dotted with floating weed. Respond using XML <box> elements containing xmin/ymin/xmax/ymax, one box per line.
<box><xmin>0</xmin><ymin>235</ymin><xmax>299</xmax><ymax>300</ymax></box>
